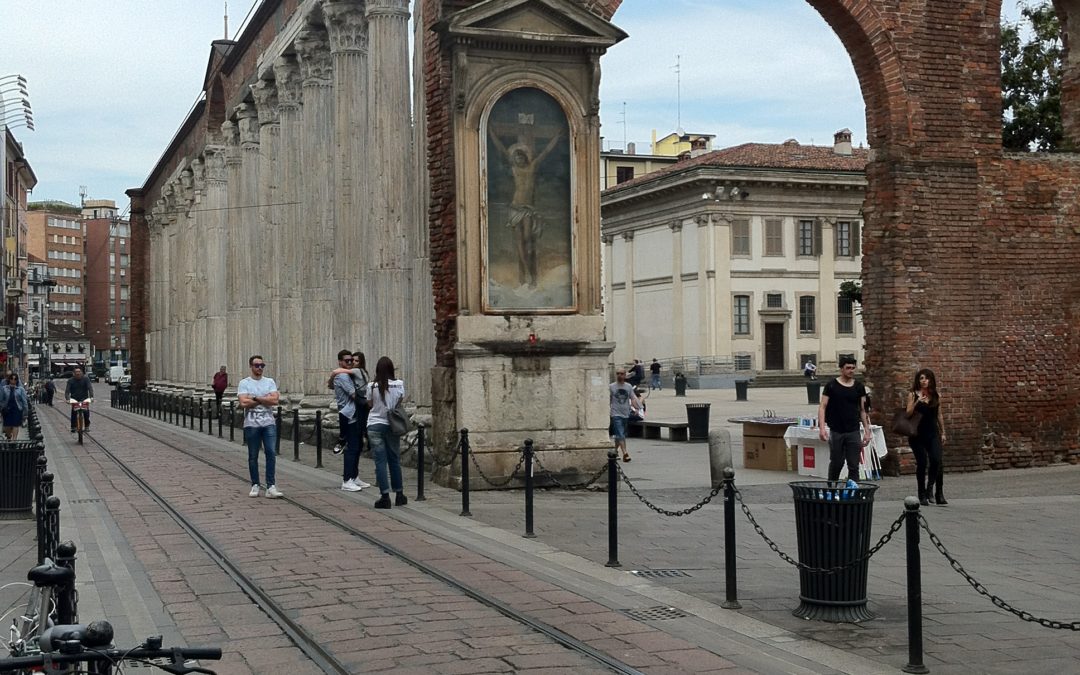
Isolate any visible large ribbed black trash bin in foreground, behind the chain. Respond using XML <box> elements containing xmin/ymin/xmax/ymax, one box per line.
<box><xmin>788</xmin><ymin>481</ymin><xmax>878</xmax><ymax>623</ymax></box>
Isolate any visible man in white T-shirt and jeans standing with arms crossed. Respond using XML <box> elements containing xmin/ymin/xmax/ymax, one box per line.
<box><xmin>237</xmin><ymin>354</ymin><xmax>283</xmax><ymax>499</ymax></box>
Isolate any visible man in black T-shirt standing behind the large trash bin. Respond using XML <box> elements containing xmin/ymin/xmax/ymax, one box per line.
<box><xmin>818</xmin><ymin>356</ymin><xmax>870</xmax><ymax>481</ymax></box>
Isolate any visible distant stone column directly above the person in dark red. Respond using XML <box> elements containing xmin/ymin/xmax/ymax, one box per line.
<box><xmin>203</xmin><ymin>146</ymin><xmax>230</xmax><ymax>380</ymax></box>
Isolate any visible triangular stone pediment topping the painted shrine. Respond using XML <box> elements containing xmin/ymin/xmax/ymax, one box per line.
<box><xmin>445</xmin><ymin>0</ymin><xmax>626</xmax><ymax>46</ymax></box>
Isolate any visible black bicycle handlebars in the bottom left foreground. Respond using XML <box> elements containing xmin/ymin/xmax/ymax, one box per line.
<box><xmin>0</xmin><ymin>621</ymin><xmax>221</xmax><ymax>675</ymax></box>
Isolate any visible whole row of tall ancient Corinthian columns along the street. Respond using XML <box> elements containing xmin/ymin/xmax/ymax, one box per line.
<box><xmin>147</xmin><ymin>0</ymin><xmax>434</xmax><ymax>400</ymax></box>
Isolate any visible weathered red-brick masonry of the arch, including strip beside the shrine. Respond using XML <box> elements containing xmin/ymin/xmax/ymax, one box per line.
<box><xmin>424</xmin><ymin>0</ymin><xmax>1080</xmax><ymax>470</ymax></box>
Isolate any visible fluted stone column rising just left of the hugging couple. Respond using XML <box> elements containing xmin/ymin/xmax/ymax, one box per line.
<box><xmin>295</xmin><ymin>27</ymin><xmax>336</xmax><ymax>396</ymax></box>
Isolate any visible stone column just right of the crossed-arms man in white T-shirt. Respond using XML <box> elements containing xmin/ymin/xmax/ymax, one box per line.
<box><xmin>272</xmin><ymin>55</ymin><xmax>307</xmax><ymax>394</ymax></box>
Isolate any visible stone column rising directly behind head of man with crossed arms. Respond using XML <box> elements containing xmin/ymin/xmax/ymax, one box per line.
<box><xmin>252</xmin><ymin>80</ymin><xmax>282</xmax><ymax>388</ymax></box>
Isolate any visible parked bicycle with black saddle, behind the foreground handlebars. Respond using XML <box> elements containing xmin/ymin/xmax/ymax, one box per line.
<box><xmin>6</xmin><ymin>558</ymin><xmax>75</xmax><ymax>657</ymax></box>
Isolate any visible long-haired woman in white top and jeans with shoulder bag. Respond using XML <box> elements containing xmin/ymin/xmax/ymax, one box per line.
<box><xmin>367</xmin><ymin>356</ymin><xmax>408</xmax><ymax>509</ymax></box>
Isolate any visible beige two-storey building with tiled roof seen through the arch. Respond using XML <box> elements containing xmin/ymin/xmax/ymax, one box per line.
<box><xmin>602</xmin><ymin>132</ymin><xmax>867</xmax><ymax>373</ymax></box>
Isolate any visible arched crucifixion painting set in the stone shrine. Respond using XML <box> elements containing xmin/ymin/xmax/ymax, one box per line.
<box><xmin>485</xmin><ymin>87</ymin><xmax>573</xmax><ymax>310</ymax></box>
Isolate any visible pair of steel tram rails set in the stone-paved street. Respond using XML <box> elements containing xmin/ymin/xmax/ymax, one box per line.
<box><xmin>52</xmin><ymin>401</ymin><xmax>642</xmax><ymax>675</ymax></box>
